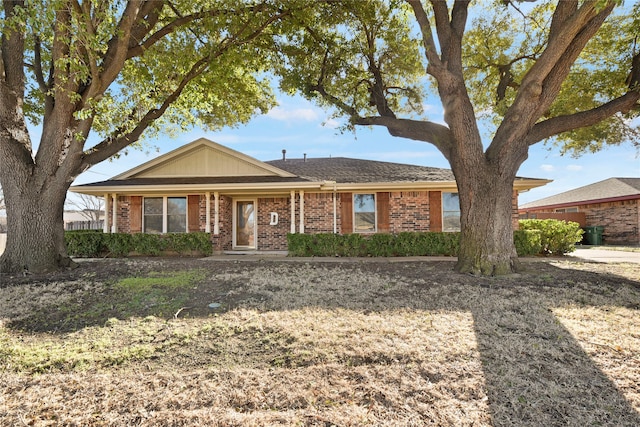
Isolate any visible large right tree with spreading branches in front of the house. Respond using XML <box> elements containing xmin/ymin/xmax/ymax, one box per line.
<box><xmin>280</xmin><ymin>0</ymin><xmax>640</xmax><ymax>274</ymax></box>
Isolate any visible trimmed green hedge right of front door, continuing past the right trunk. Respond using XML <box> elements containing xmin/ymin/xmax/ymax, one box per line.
<box><xmin>287</xmin><ymin>230</ymin><xmax>541</xmax><ymax>257</ymax></box>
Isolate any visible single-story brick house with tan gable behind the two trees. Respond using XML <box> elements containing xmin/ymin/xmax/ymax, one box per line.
<box><xmin>70</xmin><ymin>138</ymin><xmax>549</xmax><ymax>252</ymax></box>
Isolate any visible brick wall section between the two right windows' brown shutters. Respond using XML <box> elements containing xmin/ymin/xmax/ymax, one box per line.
<box><xmin>389</xmin><ymin>191</ymin><xmax>430</xmax><ymax>233</ymax></box>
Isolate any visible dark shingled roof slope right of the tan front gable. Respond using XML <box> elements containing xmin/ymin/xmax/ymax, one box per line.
<box><xmin>265</xmin><ymin>157</ymin><xmax>455</xmax><ymax>184</ymax></box>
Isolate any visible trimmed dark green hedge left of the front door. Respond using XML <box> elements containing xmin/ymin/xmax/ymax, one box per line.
<box><xmin>65</xmin><ymin>230</ymin><xmax>213</xmax><ymax>257</ymax></box>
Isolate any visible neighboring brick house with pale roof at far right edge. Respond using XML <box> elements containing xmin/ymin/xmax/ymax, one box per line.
<box><xmin>519</xmin><ymin>178</ymin><xmax>640</xmax><ymax>245</ymax></box>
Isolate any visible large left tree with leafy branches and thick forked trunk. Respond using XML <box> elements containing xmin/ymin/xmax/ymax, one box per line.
<box><xmin>0</xmin><ymin>0</ymin><xmax>293</xmax><ymax>272</ymax></box>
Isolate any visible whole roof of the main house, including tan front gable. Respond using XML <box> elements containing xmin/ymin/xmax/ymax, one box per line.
<box><xmin>70</xmin><ymin>138</ymin><xmax>549</xmax><ymax>195</ymax></box>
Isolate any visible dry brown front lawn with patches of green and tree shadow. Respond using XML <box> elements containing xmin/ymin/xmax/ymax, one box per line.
<box><xmin>0</xmin><ymin>258</ymin><xmax>640</xmax><ymax>426</ymax></box>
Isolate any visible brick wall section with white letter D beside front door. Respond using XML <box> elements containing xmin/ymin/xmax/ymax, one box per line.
<box><xmin>258</xmin><ymin>197</ymin><xmax>292</xmax><ymax>251</ymax></box>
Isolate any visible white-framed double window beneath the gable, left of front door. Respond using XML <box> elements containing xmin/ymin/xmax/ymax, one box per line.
<box><xmin>142</xmin><ymin>197</ymin><xmax>187</xmax><ymax>233</ymax></box>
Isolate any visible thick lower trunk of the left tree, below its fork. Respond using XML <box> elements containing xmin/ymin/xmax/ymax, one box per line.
<box><xmin>0</xmin><ymin>181</ymin><xmax>76</xmax><ymax>273</ymax></box>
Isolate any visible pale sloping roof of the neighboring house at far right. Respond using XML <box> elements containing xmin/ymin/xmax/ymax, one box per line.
<box><xmin>520</xmin><ymin>178</ymin><xmax>640</xmax><ymax>209</ymax></box>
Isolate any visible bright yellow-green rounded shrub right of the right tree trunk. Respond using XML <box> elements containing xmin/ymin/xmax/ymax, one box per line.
<box><xmin>519</xmin><ymin>219</ymin><xmax>584</xmax><ymax>255</ymax></box>
